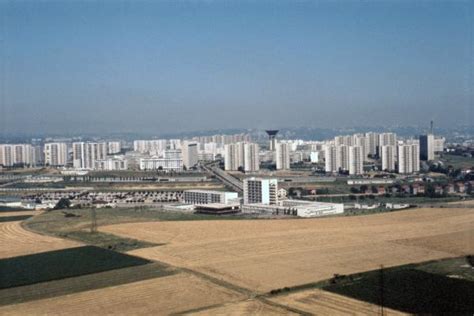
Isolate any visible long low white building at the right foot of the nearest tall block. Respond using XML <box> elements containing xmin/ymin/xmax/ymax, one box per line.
<box><xmin>242</xmin><ymin>200</ymin><xmax>344</xmax><ymax>217</ymax></box>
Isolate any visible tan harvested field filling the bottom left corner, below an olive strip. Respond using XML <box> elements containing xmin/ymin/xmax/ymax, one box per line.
<box><xmin>0</xmin><ymin>273</ymin><xmax>244</xmax><ymax>315</ymax></box>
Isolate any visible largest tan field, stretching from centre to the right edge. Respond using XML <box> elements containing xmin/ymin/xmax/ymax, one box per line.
<box><xmin>101</xmin><ymin>208</ymin><xmax>474</xmax><ymax>293</ymax></box>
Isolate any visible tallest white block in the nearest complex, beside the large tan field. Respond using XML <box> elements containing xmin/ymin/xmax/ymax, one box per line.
<box><xmin>243</xmin><ymin>177</ymin><xmax>278</xmax><ymax>205</ymax></box>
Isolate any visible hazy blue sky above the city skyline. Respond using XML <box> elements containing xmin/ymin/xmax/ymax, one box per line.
<box><xmin>0</xmin><ymin>0</ymin><xmax>474</xmax><ymax>133</ymax></box>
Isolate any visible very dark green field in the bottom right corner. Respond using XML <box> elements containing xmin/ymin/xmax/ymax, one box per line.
<box><xmin>323</xmin><ymin>262</ymin><xmax>474</xmax><ymax>315</ymax></box>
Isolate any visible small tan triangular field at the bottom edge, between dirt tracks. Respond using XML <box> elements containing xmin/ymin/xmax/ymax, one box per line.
<box><xmin>189</xmin><ymin>300</ymin><xmax>298</xmax><ymax>316</ymax></box>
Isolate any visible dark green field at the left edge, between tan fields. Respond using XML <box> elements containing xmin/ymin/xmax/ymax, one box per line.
<box><xmin>0</xmin><ymin>246</ymin><xmax>150</xmax><ymax>289</ymax></box>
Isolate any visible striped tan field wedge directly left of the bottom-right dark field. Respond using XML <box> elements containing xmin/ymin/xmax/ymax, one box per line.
<box><xmin>271</xmin><ymin>289</ymin><xmax>406</xmax><ymax>316</ymax></box>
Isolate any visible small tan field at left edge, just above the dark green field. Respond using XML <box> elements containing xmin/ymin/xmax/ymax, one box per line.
<box><xmin>0</xmin><ymin>220</ymin><xmax>81</xmax><ymax>258</ymax></box>
